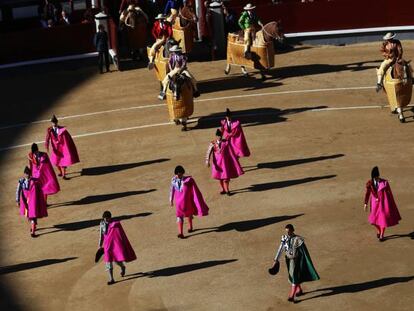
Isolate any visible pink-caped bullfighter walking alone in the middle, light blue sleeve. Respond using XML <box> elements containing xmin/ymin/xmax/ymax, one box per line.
<box><xmin>170</xmin><ymin>165</ymin><xmax>208</xmax><ymax>239</ymax></box>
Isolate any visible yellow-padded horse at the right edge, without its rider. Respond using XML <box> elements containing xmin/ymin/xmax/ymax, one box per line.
<box><xmin>384</xmin><ymin>59</ymin><xmax>413</xmax><ymax>123</ymax></box>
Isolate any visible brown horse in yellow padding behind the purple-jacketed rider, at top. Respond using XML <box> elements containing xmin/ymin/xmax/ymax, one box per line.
<box><xmin>172</xmin><ymin>5</ymin><xmax>198</xmax><ymax>53</ymax></box>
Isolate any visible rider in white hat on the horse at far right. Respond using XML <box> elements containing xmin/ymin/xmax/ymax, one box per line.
<box><xmin>376</xmin><ymin>32</ymin><xmax>403</xmax><ymax>92</ymax></box>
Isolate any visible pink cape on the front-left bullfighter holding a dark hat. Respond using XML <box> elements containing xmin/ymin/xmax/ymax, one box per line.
<box><xmin>103</xmin><ymin>221</ymin><xmax>137</xmax><ymax>262</ymax></box>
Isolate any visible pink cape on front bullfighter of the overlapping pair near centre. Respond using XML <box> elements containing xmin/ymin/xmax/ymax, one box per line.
<box><xmin>211</xmin><ymin>139</ymin><xmax>244</xmax><ymax>179</ymax></box>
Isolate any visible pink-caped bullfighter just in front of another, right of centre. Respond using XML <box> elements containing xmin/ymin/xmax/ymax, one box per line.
<box><xmin>206</xmin><ymin>129</ymin><xmax>244</xmax><ymax>195</ymax></box>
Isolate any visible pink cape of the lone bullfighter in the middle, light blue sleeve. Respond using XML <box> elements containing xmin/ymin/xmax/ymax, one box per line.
<box><xmin>171</xmin><ymin>176</ymin><xmax>208</xmax><ymax>217</ymax></box>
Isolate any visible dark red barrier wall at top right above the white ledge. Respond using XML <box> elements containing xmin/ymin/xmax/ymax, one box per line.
<box><xmin>228</xmin><ymin>0</ymin><xmax>414</xmax><ymax>33</ymax></box>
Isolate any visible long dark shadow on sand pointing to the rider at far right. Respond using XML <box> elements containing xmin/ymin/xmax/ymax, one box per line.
<box><xmin>266</xmin><ymin>60</ymin><xmax>381</xmax><ymax>79</ymax></box>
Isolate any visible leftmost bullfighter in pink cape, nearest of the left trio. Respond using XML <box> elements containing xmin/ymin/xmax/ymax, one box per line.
<box><xmin>16</xmin><ymin>166</ymin><xmax>47</xmax><ymax>238</ymax></box>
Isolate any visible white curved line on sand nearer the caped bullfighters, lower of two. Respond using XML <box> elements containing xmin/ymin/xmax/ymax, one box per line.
<box><xmin>0</xmin><ymin>105</ymin><xmax>413</xmax><ymax>152</ymax></box>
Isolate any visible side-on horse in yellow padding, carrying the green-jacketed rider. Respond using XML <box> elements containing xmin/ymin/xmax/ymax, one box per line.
<box><xmin>224</xmin><ymin>21</ymin><xmax>284</xmax><ymax>80</ymax></box>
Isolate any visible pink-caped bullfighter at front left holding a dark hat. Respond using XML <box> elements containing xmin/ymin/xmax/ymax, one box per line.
<box><xmin>99</xmin><ymin>211</ymin><xmax>137</xmax><ymax>285</ymax></box>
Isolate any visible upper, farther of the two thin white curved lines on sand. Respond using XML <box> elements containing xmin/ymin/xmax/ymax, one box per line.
<box><xmin>0</xmin><ymin>86</ymin><xmax>375</xmax><ymax>131</ymax></box>
